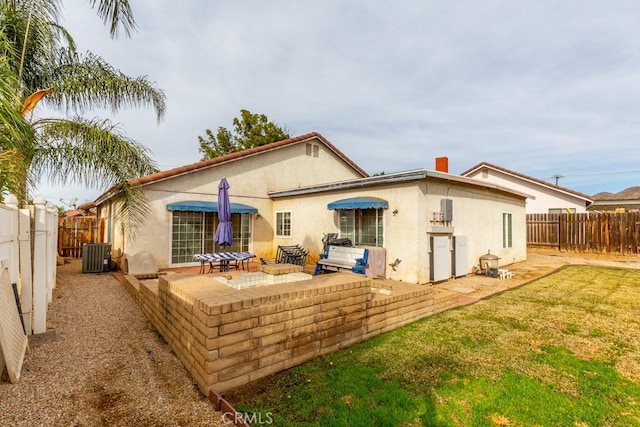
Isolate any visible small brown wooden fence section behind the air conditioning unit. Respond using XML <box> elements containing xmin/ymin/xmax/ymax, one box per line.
<box><xmin>58</xmin><ymin>216</ymin><xmax>104</xmax><ymax>258</ymax></box>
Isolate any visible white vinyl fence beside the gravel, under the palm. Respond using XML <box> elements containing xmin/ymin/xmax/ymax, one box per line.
<box><xmin>0</xmin><ymin>195</ymin><xmax>58</xmax><ymax>335</ymax></box>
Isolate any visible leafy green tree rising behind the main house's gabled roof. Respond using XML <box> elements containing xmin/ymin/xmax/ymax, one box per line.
<box><xmin>198</xmin><ymin>110</ymin><xmax>289</xmax><ymax>160</ymax></box>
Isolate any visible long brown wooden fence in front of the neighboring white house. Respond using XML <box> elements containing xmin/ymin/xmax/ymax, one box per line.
<box><xmin>527</xmin><ymin>212</ymin><xmax>640</xmax><ymax>254</ymax></box>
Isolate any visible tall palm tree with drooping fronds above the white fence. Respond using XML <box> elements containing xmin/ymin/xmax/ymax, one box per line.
<box><xmin>0</xmin><ymin>0</ymin><xmax>165</xmax><ymax>241</ymax></box>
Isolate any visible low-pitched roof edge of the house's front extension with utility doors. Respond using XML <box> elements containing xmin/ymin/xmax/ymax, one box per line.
<box><xmin>269</xmin><ymin>169</ymin><xmax>531</xmax><ymax>199</ymax></box>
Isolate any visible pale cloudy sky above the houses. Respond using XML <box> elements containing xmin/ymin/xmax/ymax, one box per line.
<box><xmin>36</xmin><ymin>0</ymin><xmax>640</xmax><ymax>207</ymax></box>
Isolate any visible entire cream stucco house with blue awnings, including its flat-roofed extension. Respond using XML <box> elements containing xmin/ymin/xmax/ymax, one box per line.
<box><xmin>95</xmin><ymin>133</ymin><xmax>527</xmax><ymax>283</ymax></box>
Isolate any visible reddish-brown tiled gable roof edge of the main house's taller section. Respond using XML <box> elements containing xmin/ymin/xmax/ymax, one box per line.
<box><xmin>95</xmin><ymin>132</ymin><xmax>369</xmax><ymax>203</ymax></box>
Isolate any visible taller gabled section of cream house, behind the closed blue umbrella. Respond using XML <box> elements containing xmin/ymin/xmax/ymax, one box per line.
<box><xmin>95</xmin><ymin>133</ymin><xmax>367</xmax><ymax>268</ymax></box>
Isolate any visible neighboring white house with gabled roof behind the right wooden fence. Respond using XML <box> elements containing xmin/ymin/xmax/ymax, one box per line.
<box><xmin>460</xmin><ymin>162</ymin><xmax>593</xmax><ymax>214</ymax></box>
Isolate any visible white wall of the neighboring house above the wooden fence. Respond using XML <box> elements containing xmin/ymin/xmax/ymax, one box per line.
<box><xmin>466</xmin><ymin>169</ymin><xmax>586</xmax><ymax>213</ymax></box>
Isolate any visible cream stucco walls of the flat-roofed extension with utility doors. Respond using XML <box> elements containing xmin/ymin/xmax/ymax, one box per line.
<box><xmin>274</xmin><ymin>179</ymin><xmax>526</xmax><ymax>283</ymax></box>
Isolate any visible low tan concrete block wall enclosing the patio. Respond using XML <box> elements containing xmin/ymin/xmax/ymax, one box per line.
<box><xmin>125</xmin><ymin>273</ymin><xmax>456</xmax><ymax>395</ymax></box>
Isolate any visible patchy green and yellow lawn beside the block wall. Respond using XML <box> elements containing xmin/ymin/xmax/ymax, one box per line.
<box><xmin>229</xmin><ymin>266</ymin><xmax>640</xmax><ymax>426</ymax></box>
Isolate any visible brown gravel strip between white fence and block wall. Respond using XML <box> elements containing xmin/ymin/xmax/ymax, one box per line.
<box><xmin>0</xmin><ymin>260</ymin><xmax>225</xmax><ymax>426</ymax></box>
